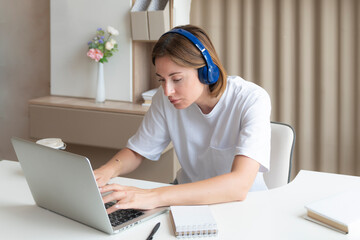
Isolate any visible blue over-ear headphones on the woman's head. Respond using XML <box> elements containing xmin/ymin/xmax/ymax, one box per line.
<box><xmin>164</xmin><ymin>28</ymin><xmax>220</xmax><ymax>84</ymax></box>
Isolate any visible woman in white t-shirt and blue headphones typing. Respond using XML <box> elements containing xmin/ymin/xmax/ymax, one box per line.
<box><xmin>94</xmin><ymin>25</ymin><xmax>271</xmax><ymax>213</ymax></box>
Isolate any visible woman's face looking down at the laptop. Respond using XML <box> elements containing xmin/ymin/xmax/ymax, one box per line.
<box><xmin>155</xmin><ymin>56</ymin><xmax>208</xmax><ymax>109</ymax></box>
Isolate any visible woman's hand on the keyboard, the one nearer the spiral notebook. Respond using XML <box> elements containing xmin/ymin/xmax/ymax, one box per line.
<box><xmin>100</xmin><ymin>184</ymin><xmax>158</xmax><ymax>214</ymax></box>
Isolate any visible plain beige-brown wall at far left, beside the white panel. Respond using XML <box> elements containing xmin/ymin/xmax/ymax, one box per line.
<box><xmin>0</xmin><ymin>0</ymin><xmax>50</xmax><ymax>160</ymax></box>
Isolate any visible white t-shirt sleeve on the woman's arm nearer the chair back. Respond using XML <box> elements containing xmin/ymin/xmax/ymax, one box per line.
<box><xmin>236</xmin><ymin>89</ymin><xmax>271</xmax><ymax>172</ymax></box>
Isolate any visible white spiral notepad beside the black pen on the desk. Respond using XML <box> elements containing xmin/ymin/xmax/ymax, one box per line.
<box><xmin>170</xmin><ymin>205</ymin><xmax>219</xmax><ymax>238</ymax></box>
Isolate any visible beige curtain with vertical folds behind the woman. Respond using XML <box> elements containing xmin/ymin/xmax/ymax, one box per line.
<box><xmin>191</xmin><ymin>0</ymin><xmax>360</xmax><ymax>176</ymax></box>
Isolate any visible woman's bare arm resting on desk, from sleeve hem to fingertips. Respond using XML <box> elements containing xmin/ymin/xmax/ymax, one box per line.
<box><xmin>101</xmin><ymin>156</ymin><xmax>260</xmax><ymax>213</ymax></box>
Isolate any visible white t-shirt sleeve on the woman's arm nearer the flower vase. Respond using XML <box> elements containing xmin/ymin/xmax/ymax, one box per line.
<box><xmin>126</xmin><ymin>88</ymin><xmax>170</xmax><ymax>160</ymax></box>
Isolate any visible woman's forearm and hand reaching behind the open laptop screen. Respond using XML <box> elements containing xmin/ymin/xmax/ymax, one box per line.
<box><xmin>94</xmin><ymin>148</ymin><xmax>143</xmax><ymax>187</ymax></box>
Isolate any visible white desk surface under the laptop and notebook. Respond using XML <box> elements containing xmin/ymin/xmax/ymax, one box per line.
<box><xmin>0</xmin><ymin>161</ymin><xmax>360</xmax><ymax>240</ymax></box>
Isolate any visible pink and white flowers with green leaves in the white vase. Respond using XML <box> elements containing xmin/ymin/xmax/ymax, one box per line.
<box><xmin>87</xmin><ymin>26</ymin><xmax>119</xmax><ymax>63</ymax></box>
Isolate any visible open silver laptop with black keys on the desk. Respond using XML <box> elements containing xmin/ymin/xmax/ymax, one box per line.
<box><xmin>11</xmin><ymin>138</ymin><xmax>167</xmax><ymax>234</ymax></box>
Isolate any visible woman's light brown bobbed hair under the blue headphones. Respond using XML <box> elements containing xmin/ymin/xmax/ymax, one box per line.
<box><xmin>152</xmin><ymin>25</ymin><xmax>227</xmax><ymax>97</ymax></box>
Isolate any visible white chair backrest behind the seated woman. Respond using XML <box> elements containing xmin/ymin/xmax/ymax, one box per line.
<box><xmin>264</xmin><ymin>122</ymin><xmax>295</xmax><ymax>189</ymax></box>
